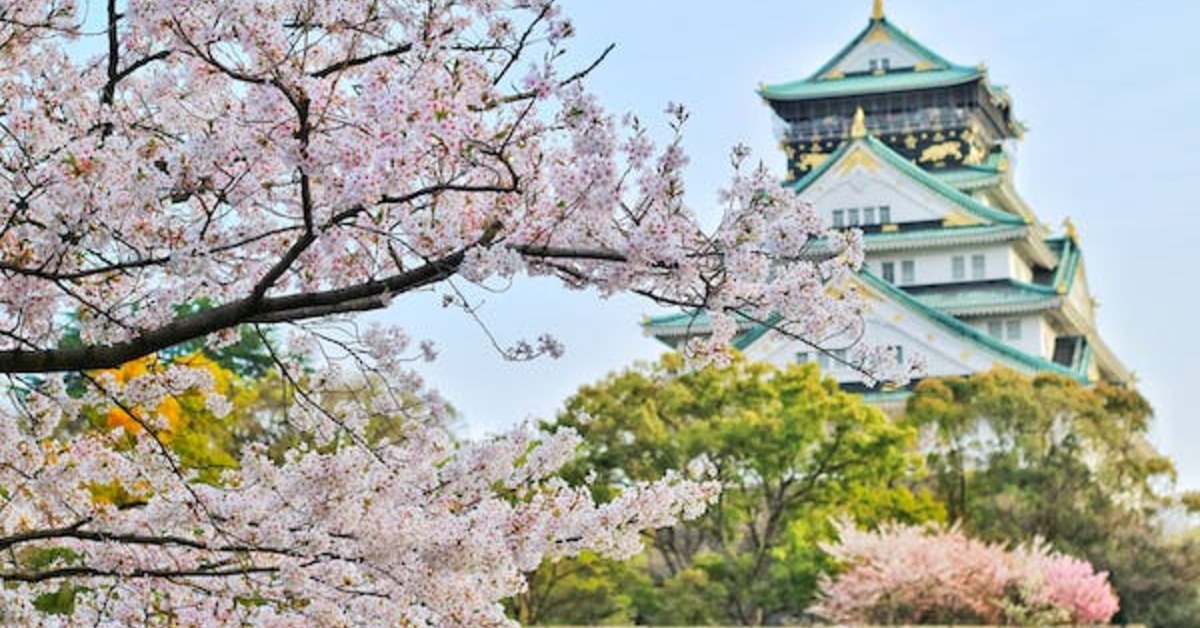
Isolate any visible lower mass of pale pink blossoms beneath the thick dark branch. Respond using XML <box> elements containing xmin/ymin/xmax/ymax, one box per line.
<box><xmin>0</xmin><ymin>379</ymin><xmax>715</xmax><ymax>626</ymax></box>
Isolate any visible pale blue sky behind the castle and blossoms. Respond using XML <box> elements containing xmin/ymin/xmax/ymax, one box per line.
<box><xmin>386</xmin><ymin>0</ymin><xmax>1200</xmax><ymax>488</ymax></box>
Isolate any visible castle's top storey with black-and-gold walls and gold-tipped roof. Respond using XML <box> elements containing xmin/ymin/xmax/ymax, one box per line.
<box><xmin>760</xmin><ymin>5</ymin><xmax>1022</xmax><ymax>179</ymax></box>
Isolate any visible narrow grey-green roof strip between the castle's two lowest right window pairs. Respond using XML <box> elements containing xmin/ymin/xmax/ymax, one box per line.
<box><xmin>906</xmin><ymin>280</ymin><xmax>1062</xmax><ymax>316</ymax></box>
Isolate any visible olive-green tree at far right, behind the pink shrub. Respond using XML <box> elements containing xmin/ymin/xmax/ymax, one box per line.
<box><xmin>902</xmin><ymin>370</ymin><xmax>1200</xmax><ymax>626</ymax></box>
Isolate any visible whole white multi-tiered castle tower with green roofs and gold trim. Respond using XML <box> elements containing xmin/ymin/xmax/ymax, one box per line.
<box><xmin>644</xmin><ymin>0</ymin><xmax>1132</xmax><ymax>402</ymax></box>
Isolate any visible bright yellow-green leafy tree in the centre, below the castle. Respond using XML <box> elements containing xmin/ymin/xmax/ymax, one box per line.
<box><xmin>538</xmin><ymin>355</ymin><xmax>942</xmax><ymax>624</ymax></box>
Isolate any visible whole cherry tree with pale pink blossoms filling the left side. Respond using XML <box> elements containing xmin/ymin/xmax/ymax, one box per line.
<box><xmin>0</xmin><ymin>0</ymin><xmax>860</xmax><ymax>626</ymax></box>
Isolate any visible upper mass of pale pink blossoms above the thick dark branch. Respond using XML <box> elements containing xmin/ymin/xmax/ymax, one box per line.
<box><xmin>0</xmin><ymin>0</ymin><xmax>862</xmax><ymax>362</ymax></box>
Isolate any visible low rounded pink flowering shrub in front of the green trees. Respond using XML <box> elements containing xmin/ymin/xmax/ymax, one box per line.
<box><xmin>811</xmin><ymin>522</ymin><xmax>1118</xmax><ymax>626</ymax></box>
